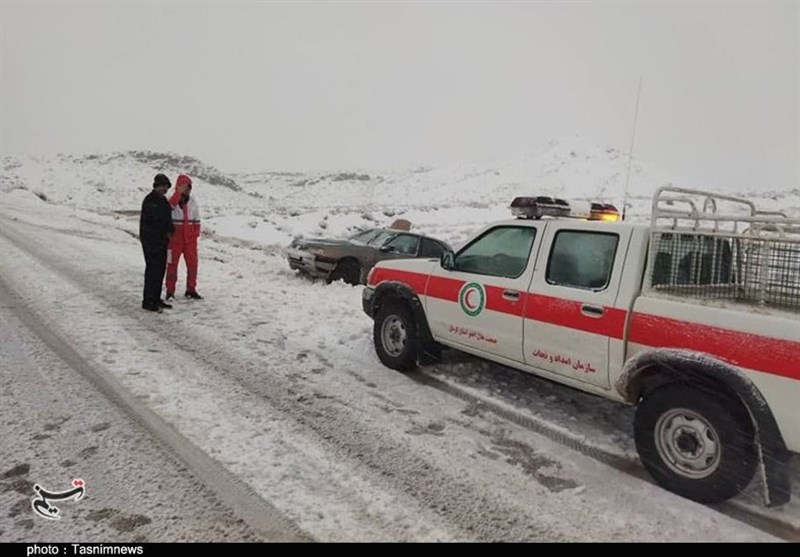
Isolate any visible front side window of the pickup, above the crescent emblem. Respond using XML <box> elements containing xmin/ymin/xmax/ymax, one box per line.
<box><xmin>455</xmin><ymin>226</ymin><xmax>536</xmax><ymax>278</ymax></box>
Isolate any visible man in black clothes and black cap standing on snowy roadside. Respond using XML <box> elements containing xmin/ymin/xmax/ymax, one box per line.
<box><xmin>139</xmin><ymin>174</ymin><xmax>175</xmax><ymax>313</ymax></box>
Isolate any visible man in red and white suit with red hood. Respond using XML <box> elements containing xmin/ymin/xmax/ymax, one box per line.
<box><xmin>167</xmin><ymin>174</ymin><xmax>203</xmax><ymax>300</ymax></box>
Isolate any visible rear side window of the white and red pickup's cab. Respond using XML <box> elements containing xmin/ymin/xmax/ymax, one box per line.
<box><xmin>545</xmin><ymin>230</ymin><xmax>619</xmax><ymax>290</ymax></box>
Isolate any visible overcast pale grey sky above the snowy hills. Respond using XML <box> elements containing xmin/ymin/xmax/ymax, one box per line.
<box><xmin>0</xmin><ymin>0</ymin><xmax>800</xmax><ymax>188</ymax></box>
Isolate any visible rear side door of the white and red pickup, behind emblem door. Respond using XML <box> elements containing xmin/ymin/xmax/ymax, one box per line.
<box><xmin>524</xmin><ymin>221</ymin><xmax>631</xmax><ymax>388</ymax></box>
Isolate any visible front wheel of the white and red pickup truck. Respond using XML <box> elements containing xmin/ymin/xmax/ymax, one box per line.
<box><xmin>372</xmin><ymin>303</ymin><xmax>419</xmax><ymax>371</ymax></box>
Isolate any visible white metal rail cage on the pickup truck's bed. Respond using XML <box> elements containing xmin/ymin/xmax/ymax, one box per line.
<box><xmin>644</xmin><ymin>186</ymin><xmax>800</xmax><ymax>311</ymax></box>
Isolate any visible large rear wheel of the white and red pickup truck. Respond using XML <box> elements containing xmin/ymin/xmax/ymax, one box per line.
<box><xmin>634</xmin><ymin>383</ymin><xmax>758</xmax><ymax>503</ymax></box>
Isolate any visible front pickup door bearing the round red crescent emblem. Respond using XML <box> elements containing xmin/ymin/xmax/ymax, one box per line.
<box><xmin>425</xmin><ymin>221</ymin><xmax>543</xmax><ymax>363</ymax></box>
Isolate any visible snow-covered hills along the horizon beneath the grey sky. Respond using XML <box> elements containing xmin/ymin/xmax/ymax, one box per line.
<box><xmin>0</xmin><ymin>137</ymin><xmax>800</xmax><ymax>250</ymax></box>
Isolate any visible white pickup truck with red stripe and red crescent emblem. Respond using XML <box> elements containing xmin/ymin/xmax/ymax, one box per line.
<box><xmin>362</xmin><ymin>187</ymin><xmax>800</xmax><ymax>506</ymax></box>
